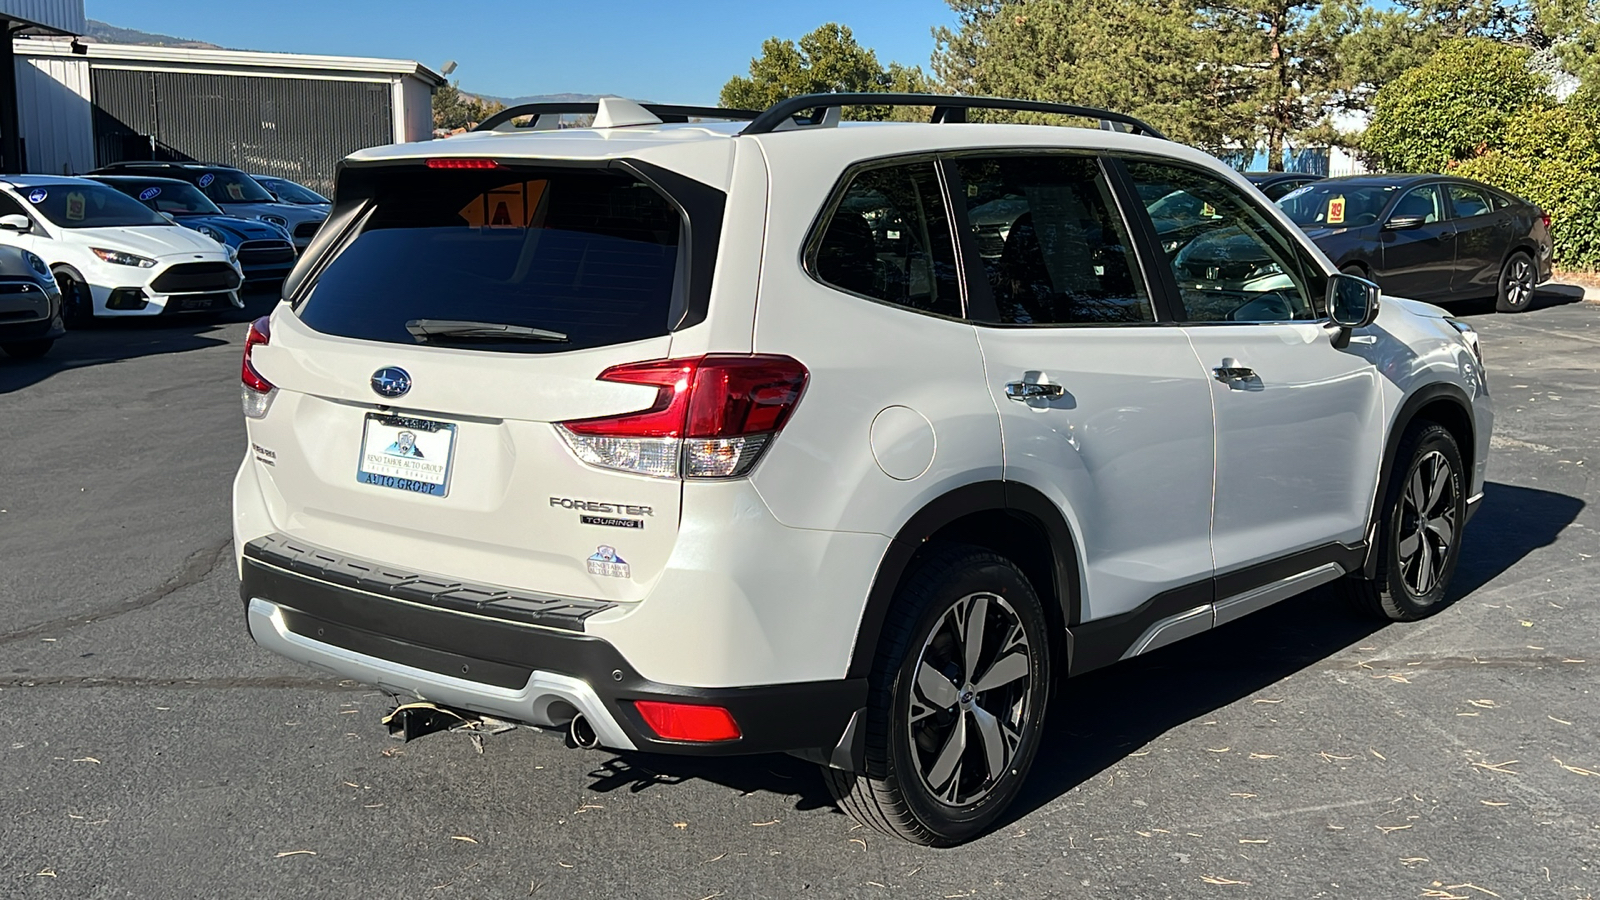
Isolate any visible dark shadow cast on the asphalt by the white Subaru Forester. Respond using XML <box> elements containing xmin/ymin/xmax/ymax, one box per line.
<box><xmin>589</xmin><ymin>482</ymin><xmax>1584</xmax><ymax>830</ymax></box>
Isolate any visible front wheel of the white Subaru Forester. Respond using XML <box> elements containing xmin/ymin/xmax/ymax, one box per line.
<box><xmin>1338</xmin><ymin>421</ymin><xmax>1467</xmax><ymax>621</ymax></box>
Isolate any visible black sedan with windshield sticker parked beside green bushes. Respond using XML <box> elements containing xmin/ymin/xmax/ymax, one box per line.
<box><xmin>1278</xmin><ymin>175</ymin><xmax>1552</xmax><ymax>312</ymax></box>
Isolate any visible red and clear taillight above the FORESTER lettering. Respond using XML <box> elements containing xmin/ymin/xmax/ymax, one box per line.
<box><xmin>558</xmin><ymin>356</ymin><xmax>808</xmax><ymax>479</ymax></box>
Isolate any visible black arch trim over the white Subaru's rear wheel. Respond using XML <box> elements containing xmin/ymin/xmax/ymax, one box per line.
<box><xmin>845</xmin><ymin>480</ymin><xmax>1082</xmax><ymax>679</ymax></box>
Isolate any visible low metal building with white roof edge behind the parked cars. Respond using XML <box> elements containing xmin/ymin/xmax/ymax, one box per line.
<box><xmin>14</xmin><ymin>38</ymin><xmax>445</xmax><ymax>194</ymax></box>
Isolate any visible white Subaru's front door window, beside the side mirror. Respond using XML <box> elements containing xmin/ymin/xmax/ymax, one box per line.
<box><xmin>1126</xmin><ymin>160</ymin><xmax>1318</xmax><ymax>322</ymax></box>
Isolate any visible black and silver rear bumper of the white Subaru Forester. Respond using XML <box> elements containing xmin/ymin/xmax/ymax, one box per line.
<box><xmin>240</xmin><ymin>541</ymin><xmax>867</xmax><ymax>755</ymax></box>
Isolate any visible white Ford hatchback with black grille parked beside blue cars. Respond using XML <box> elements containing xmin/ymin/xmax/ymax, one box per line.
<box><xmin>0</xmin><ymin>175</ymin><xmax>243</xmax><ymax>323</ymax></box>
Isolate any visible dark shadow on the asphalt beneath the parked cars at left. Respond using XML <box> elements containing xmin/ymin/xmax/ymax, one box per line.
<box><xmin>0</xmin><ymin>283</ymin><xmax>278</xmax><ymax>394</ymax></box>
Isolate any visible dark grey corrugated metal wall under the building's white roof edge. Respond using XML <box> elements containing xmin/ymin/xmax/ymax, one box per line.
<box><xmin>91</xmin><ymin>66</ymin><xmax>394</xmax><ymax>194</ymax></box>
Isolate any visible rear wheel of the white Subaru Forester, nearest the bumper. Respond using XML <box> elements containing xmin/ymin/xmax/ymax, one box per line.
<box><xmin>824</xmin><ymin>546</ymin><xmax>1051</xmax><ymax>846</ymax></box>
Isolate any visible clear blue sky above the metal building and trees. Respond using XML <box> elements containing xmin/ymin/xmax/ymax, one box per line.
<box><xmin>86</xmin><ymin>0</ymin><xmax>954</xmax><ymax>104</ymax></box>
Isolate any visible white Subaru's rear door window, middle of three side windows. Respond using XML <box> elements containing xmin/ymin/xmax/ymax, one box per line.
<box><xmin>957</xmin><ymin>155</ymin><xmax>1155</xmax><ymax>325</ymax></box>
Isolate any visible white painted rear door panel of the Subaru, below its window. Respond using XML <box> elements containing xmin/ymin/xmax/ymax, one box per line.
<box><xmin>978</xmin><ymin>325</ymin><xmax>1214</xmax><ymax>620</ymax></box>
